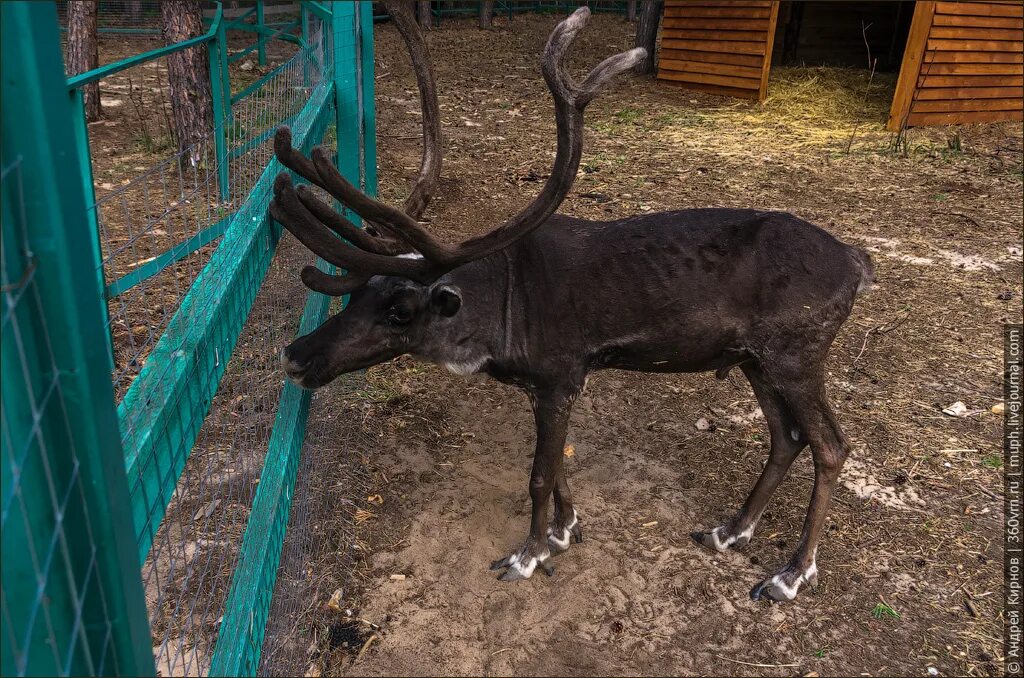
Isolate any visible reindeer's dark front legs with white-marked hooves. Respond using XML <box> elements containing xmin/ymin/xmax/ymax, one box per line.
<box><xmin>490</xmin><ymin>390</ymin><xmax>582</xmax><ymax>582</ymax></box>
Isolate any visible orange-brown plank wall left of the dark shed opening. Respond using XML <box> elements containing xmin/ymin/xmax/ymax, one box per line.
<box><xmin>657</xmin><ymin>0</ymin><xmax>778</xmax><ymax>100</ymax></box>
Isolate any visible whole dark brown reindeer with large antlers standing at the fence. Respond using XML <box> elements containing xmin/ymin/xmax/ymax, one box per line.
<box><xmin>270</xmin><ymin>2</ymin><xmax>871</xmax><ymax>600</ymax></box>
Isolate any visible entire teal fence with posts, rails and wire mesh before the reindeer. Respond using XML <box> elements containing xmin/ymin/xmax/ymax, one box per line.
<box><xmin>0</xmin><ymin>2</ymin><xmax>376</xmax><ymax>675</ymax></box>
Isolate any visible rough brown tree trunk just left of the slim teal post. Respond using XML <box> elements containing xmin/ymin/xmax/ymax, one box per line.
<box><xmin>160</xmin><ymin>0</ymin><xmax>213</xmax><ymax>165</ymax></box>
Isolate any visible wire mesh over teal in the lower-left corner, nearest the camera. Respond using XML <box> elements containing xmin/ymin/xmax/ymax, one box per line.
<box><xmin>0</xmin><ymin>159</ymin><xmax>117</xmax><ymax>675</ymax></box>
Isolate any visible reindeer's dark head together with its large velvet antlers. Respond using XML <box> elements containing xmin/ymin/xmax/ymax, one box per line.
<box><xmin>270</xmin><ymin>0</ymin><xmax>645</xmax><ymax>388</ymax></box>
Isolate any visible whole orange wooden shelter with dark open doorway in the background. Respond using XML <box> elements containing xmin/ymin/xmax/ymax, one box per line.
<box><xmin>657</xmin><ymin>0</ymin><xmax>1024</xmax><ymax>130</ymax></box>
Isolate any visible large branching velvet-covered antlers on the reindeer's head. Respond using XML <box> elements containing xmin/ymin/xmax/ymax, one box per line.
<box><xmin>270</xmin><ymin>7</ymin><xmax>646</xmax><ymax>296</ymax></box>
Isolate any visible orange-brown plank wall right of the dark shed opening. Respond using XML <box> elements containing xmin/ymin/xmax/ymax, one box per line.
<box><xmin>889</xmin><ymin>0</ymin><xmax>1024</xmax><ymax>131</ymax></box>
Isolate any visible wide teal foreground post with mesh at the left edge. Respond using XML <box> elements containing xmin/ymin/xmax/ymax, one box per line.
<box><xmin>0</xmin><ymin>2</ymin><xmax>155</xmax><ymax>675</ymax></box>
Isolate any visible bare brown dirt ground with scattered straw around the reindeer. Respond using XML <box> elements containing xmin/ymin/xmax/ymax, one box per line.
<box><xmin>294</xmin><ymin>11</ymin><xmax>1022</xmax><ymax>675</ymax></box>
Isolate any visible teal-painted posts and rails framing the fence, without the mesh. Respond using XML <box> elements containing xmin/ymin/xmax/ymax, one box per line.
<box><xmin>0</xmin><ymin>1</ymin><xmax>377</xmax><ymax>675</ymax></box>
